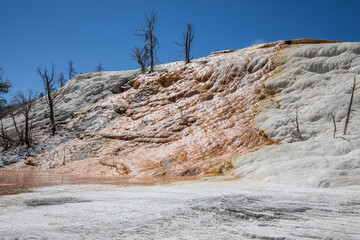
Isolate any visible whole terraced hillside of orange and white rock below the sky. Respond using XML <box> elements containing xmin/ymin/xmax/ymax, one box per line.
<box><xmin>0</xmin><ymin>39</ymin><xmax>360</xmax><ymax>187</ymax></box>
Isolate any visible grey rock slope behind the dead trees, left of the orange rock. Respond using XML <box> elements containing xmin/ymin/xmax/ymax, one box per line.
<box><xmin>0</xmin><ymin>70</ymin><xmax>140</xmax><ymax>167</ymax></box>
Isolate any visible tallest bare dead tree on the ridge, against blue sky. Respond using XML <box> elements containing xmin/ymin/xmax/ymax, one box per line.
<box><xmin>135</xmin><ymin>11</ymin><xmax>159</xmax><ymax>72</ymax></box>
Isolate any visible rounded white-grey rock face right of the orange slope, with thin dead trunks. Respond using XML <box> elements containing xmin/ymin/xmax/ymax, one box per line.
<box><xmin>234</xmin><ymin>43</ymin><xmax>360</xmax><ymax>187</ymax></box>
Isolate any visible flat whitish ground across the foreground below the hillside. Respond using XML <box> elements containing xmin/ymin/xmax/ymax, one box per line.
<box><xmin>0</xmin><ymin>179</ymin><xmax>360</xmax><ymax>239</ymax></box>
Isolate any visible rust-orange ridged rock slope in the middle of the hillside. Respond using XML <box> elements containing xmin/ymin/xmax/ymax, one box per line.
<box><xmin>11</xmin><ymin>43</ymin><xmax>277</xmax><ymax>177</ymax></box>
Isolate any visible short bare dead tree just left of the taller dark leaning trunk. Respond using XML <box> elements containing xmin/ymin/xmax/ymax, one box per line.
<box><xmin>15</xmin><ymin>90</ymin><xmax>34</xmax><ymax>147</ymax></box>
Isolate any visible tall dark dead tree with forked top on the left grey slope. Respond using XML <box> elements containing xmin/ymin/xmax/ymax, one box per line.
<box><xmin>37</xmin><ymin>63</ymin><xmax>56</xmax><ymax>135</ymax></box>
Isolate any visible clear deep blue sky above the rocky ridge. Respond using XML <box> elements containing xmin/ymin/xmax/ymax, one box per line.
<box><xmin>0</xmin><ymin>0</ymin><xmax>360</xmax><ymax>99</ymax></box>
